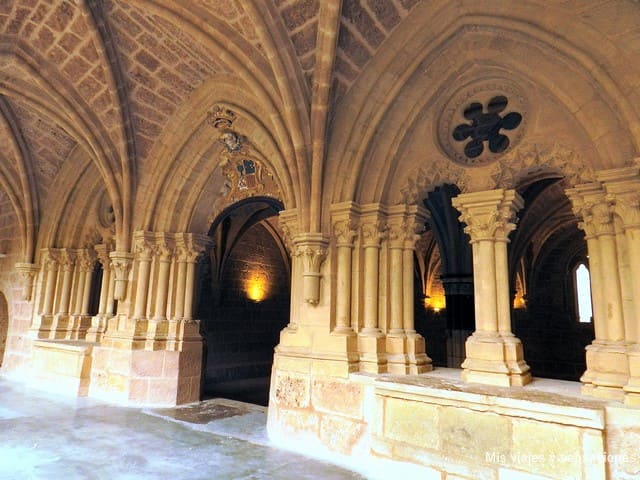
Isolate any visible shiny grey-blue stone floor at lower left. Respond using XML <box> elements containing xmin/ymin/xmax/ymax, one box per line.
<box><xmin>0</xmin><ymin>378</ymin><xmax>368</xmax><ymax>480</ymax></box>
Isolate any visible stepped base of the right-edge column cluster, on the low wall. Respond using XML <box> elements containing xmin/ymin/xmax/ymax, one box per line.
<box><xmin>580</xmin><ymin>341</ymin><xmax>629</xmax><ymax>400</ymax></box>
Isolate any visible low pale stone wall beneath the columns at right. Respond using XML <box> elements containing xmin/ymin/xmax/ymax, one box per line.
<box><xmin>269</xmin><ymin>371</ymin><xmax>640</xmax><ymax>480</ymax></box>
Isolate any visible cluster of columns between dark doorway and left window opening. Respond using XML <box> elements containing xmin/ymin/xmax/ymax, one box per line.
<box><xmin>324</xmin><ymin>202</ymin><xmax>431</xmax><ymax>374</ymax></box>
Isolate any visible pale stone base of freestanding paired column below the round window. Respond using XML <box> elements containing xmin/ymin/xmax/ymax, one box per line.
<box><xmin>462</xmin><ymin>332</ymin><xmax>531</xmax><ymax>387</ymax></box>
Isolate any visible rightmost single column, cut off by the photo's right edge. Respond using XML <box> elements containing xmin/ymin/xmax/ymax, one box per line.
<box><xmin>597</xmin><ymin>163</ymin><xmax>640</xmax><ymax>405</ymax></box>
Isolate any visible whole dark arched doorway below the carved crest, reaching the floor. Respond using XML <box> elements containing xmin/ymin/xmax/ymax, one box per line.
<box><xmin>199</xmin><ymin>197</ymin><xmax>291</xmax><ymax>405</ymax></box>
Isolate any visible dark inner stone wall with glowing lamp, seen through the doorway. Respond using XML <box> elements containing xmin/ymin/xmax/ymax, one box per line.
<box><xmin>201</xmin><ymin>224</ymin><xmax>289</xmax><ymax>388</ymax></box>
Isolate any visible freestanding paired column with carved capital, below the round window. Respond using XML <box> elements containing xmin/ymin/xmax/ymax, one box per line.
<box><xmin>452</xmin><ymin>190</ymin><xmax>531</xmax><ymax>386</ymax></box>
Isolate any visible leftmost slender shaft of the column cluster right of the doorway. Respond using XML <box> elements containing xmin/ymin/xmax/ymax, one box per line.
<box><xmin>333</xmin><ymin>218</ymin><xmax>356</xmax><ymax>334</ymax></box>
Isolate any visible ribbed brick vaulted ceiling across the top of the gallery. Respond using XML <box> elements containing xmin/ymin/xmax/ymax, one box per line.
<box><xmin>0</xmin><ymin>0</ymin><xmax>640</xmax><ymax>261</ymax></box>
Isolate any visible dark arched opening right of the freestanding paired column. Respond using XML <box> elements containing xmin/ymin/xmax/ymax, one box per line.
<box><xmin>509</xmin><ymin>177</ymin><xmax>594</xmax><ymax>381</ymax></box>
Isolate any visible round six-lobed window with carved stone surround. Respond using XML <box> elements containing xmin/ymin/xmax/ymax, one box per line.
<box><xmin>437</xmin><ymin>81</ymin><xmax>528</xmax><ymax>166</ymax></box>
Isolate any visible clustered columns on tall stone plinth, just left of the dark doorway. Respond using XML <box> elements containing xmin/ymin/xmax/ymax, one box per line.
<box><xmin>89</xmin><ymin>231</ymin><xmax>206</xmax><ymax>405</ymax></box>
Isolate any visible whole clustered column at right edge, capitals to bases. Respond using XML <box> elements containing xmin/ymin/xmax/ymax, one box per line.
<box><xmin>567</xmin><ymin>160</ymin><xmax>640</xmax><ymax>405</ymax></box>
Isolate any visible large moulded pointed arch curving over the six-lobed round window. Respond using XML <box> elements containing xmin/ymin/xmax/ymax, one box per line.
<box><xmin>326</xmin><ymin>1</ymin><xmax>638</xmax><ymax>212</ymax></box>
